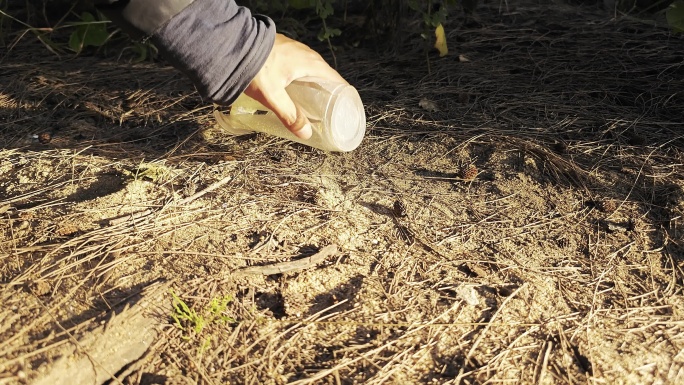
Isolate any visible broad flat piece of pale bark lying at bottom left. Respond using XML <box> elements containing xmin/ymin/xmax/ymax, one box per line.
<box><xmin>31</xmin><ymin>283</ymin><xmax>171</xmax><ymax>385</ymax></box>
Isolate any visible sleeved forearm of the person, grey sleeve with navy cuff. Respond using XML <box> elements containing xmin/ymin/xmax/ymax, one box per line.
<box><xmin>96</xmin><ymin>0</ymin><xmax>275</xmax><ymax>104</ymax></box>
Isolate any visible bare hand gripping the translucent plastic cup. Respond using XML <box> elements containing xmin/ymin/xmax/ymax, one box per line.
<box><xmin>245</xmin><ymin>34</ymin><xmax>348</xmax><ymax>139</ymax></box>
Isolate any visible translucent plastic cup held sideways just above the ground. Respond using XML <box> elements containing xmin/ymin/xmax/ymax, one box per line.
<box><xmin>214</xmin><ymin>78</ymin><xmax>366</xmax><ymax>152</ymax></box>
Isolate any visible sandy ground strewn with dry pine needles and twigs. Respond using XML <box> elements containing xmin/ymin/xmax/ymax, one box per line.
<box><xmin>0</xmin><ymin>1</ymin><xmax>684</xmax><ymax>384</ymax></box>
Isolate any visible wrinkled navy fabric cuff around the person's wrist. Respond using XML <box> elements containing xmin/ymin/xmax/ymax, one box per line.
<box><xmin>152</xmin><ymin>0</ymin><xmax>275</xmax><ymax>105</ymax></box>
